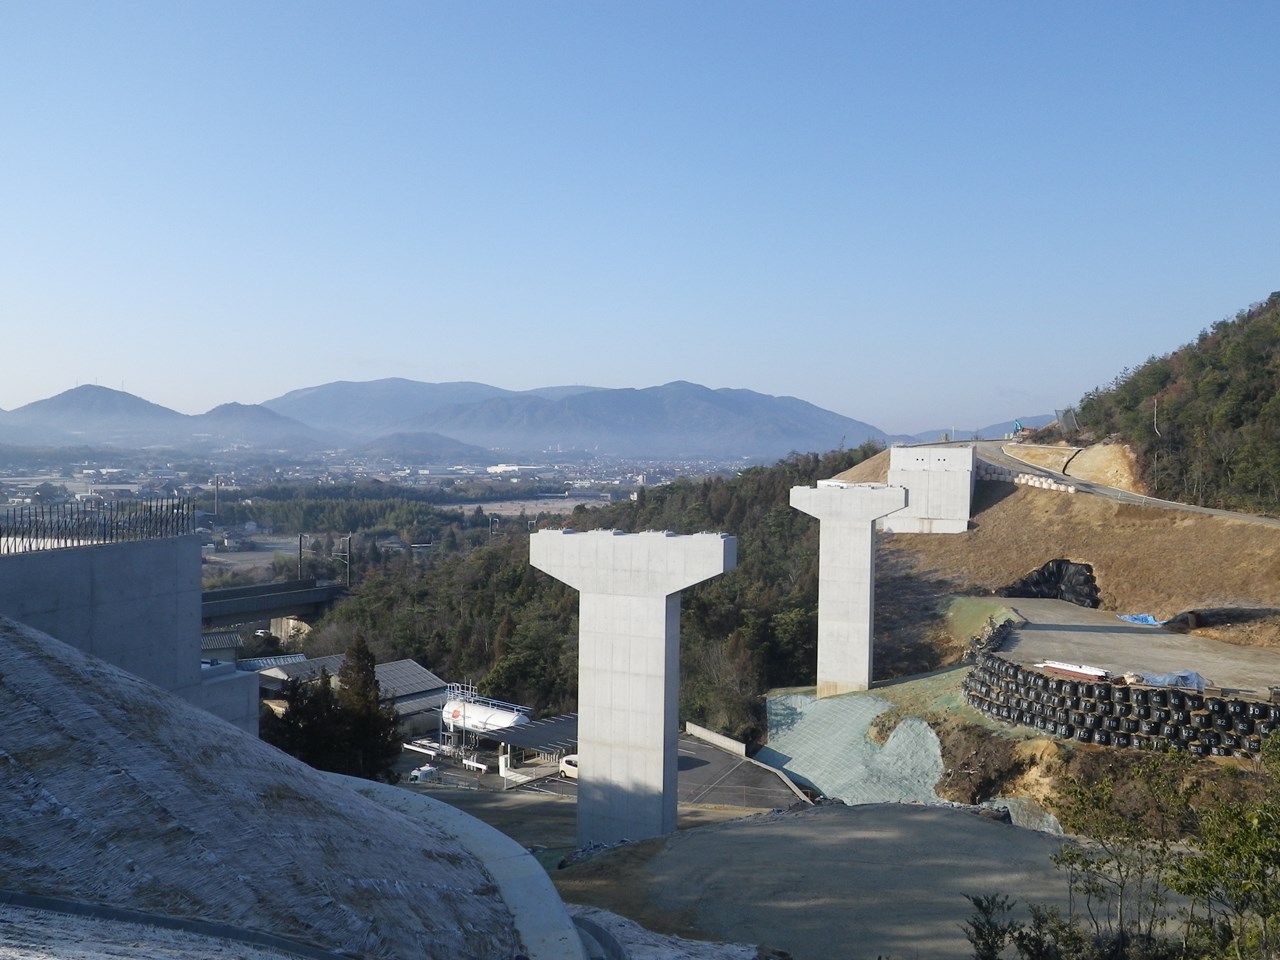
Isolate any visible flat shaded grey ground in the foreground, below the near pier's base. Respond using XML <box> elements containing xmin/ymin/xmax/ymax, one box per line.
<box><xmin>619</xmin><ymin>804</ymin><xmax>1068</xmax><ymax>960</ymax></box>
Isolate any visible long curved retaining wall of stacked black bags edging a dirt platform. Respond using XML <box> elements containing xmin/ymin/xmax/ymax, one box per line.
<box><xmin>964</xmin><ymin>654</ymin><xmax>1280</xmax><ymax>759</ymax></box>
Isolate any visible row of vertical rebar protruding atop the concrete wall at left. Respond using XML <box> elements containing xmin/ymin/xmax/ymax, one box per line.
<box><xmin>0</xmin><ymin>497</ymin><xmax>195</xmax><ymax>554</ymax></box>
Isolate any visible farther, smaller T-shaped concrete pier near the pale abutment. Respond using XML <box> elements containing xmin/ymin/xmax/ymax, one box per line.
<box><xmin>791</xmin><ymin>480</ymin><xmax>906</xmax><ymax>698</ymax></box>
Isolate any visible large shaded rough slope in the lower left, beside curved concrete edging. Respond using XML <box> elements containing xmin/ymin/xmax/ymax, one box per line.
<box><xmin>0</xmin><ymin>618</ymin><xmax>521</xmax><ymax>960</ymax></box>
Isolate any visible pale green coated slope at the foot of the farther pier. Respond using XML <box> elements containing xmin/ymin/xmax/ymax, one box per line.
<box><xmin>755</xmin><ymin>694</ymin><xmax>943</xmax><ymax>804</ymax></box>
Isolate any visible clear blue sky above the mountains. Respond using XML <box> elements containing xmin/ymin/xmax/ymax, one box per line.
<box><xmin>0</xmin><ymin>0</ymin><xmax>1280</xmax><ymax>433</ymax></box>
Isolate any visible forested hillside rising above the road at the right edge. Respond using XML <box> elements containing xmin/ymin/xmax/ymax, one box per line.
<box><xmin>1079</xmin><ymin>293</ymin><xmax>1280</xmax><ymax>513</ymax></box>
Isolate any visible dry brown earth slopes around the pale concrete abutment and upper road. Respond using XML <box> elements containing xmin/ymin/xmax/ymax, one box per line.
<box><xmin>838</xmin><ymin>444</ymin><xmax>1280</xmax><ymax>645</ymax></box>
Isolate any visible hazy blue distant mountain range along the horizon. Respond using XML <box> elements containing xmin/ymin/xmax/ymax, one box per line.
<box><xmin>0</xmin><ymin>379</ymin><xmax>1048</xmax><ymax>463</ymax></box>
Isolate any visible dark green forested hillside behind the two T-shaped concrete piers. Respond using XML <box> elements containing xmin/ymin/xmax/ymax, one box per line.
<box><xmin>308</xmin><ymin>444</ymin><xmax>879</xmax><ymax>736</ymax></box>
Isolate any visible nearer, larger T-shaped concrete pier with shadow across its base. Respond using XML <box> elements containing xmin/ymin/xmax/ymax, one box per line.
<box><xmin>529</xmin><ymin>530</ymin><xmax>737</xmax><ymax>846</ymax></box>
